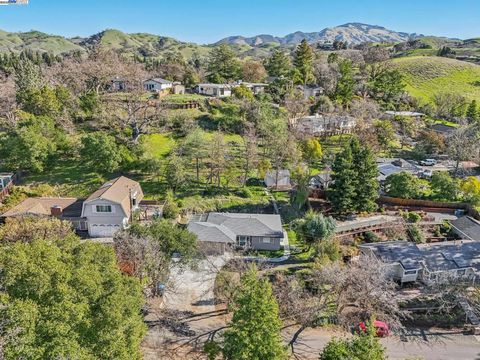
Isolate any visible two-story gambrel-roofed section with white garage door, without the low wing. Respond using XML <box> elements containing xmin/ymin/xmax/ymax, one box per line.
<box><xmin>81</xmin><ymin>176</ymin><xmax>143</xmax><ymax>237</ymax></box>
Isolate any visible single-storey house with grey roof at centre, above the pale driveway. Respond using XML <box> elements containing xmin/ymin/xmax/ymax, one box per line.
<box><xmin>188</xmin><ymin>213</ymin><xmax>285</xmax><ymax>252</ymax></box>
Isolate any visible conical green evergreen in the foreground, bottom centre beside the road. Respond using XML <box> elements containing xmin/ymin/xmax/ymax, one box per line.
<box><xmin>223</xmin><ymin>267</ymin><xmax>286</xmax><ymax>360</ymax></box>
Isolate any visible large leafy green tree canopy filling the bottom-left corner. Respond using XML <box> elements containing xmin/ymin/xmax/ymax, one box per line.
<box><xmin>0</xmin><ymin>222</ymin><xmax>146</xmax><ymax>360</ymax></box>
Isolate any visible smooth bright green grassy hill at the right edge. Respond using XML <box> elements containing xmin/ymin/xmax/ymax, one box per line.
<box><xmin>393</xmin><ymin>56</ymin><xmax>480</xmax><ymax>102</ymax></box>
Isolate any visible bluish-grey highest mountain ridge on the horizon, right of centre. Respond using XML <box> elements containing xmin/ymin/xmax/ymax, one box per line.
<box><xmin>215</xmin><ymin>23</ymin><xmax>423</xmax><ymax>46</ymax></box>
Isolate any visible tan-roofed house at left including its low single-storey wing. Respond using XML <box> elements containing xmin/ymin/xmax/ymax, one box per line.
<box><xmin>1</xmin><ymin>176</ymin><xmax>143</xmax><ymax>237</ymax></box>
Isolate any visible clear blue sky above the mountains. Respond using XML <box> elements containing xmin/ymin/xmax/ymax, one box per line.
<box><xmin>0</xmin><ymin>0</ymin><xmax>480</xmax><ymax>43</ymax></box>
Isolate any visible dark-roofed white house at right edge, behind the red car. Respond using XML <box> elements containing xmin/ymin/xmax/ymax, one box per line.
<box><xmin>359</xmin><ymin>241</ymin><xmax>480</xmax><ymax>285</ymax></box>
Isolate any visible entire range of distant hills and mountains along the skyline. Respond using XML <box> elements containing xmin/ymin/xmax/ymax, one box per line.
<box><xmin>0</xmin><ymin>23</ymin><xmax>464</xmax><ymax>60</ymax></box>
